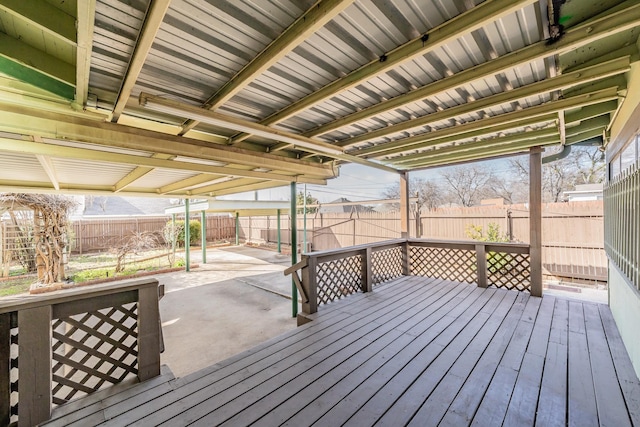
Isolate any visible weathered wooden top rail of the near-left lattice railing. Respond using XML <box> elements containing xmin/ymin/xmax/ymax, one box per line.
<box><xmin>0</xmin><ymin>277</ymin><xmax>158</xmax><ymax>314</ymax></box>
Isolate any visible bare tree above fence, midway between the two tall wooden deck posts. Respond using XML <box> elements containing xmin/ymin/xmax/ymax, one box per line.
<box><xmin>442</xmin><ymin>165</ymin><xmax>494</xmax><ymax>206</ymax></box>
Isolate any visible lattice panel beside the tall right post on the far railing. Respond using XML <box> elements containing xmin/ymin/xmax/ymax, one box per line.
<box><xmin>487</xmin><ymin>252</ymin><xmax>531</xmax><ymax>291</ymax></box>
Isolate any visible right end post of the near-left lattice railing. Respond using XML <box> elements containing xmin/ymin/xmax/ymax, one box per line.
<box><xmin>137</xmin><ymin>281</ymin><xmax>160</xmax><ymax>382</ymax></box>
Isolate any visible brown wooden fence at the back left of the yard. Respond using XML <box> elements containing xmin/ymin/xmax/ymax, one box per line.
<box><xmin>71</xmin><ymin>215</ymin><xmax>236</xmax><ymax>254</ymax></box>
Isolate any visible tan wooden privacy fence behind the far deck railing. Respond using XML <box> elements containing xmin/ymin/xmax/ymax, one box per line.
<box><xmin>240</xmin><ymin>201</ymin><xmax>607</xmax><ymax>282</ymax></box>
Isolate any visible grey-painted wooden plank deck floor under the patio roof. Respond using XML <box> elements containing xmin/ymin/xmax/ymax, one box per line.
<box><xmin>46</xmin><ymin>277</ymin><xmax>640</xmax><ymax>427</ymax></box>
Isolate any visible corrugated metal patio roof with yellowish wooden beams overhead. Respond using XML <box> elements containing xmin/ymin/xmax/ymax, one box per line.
<box><xmin>0</xmin><ymin>0</ymin><xmax>640</xmax><ymax>195</ymax></box>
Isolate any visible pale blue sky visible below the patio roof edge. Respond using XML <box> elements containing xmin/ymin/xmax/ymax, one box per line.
<box><xmin>221</xmin><ymin>155</ymin><xmax>528</xmax><ymax>203</ymax></box>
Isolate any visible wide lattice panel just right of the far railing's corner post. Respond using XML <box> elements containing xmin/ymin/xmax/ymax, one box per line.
<box><xmin>410</xmin><ymin>246</ymin><xmax>477</xmax><ymax>283</ymax></box>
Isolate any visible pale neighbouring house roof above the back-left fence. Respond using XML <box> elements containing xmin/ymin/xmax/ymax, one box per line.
<box><xmin>82</xmin><ymin>196</ymin><xmax>172</xmax><ymax>217</ymax></box>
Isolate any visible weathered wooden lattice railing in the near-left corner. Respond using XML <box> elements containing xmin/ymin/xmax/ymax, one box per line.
<box><xmin>0</xmin><ymin>278</ymin><xmax>161</xmax><ymax>426</ymax></box>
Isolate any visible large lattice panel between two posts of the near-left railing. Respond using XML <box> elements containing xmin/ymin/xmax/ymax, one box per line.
<box><xmin>52</xmin><ymin>303</ymin><xmax>138</xmax><ymax>405</ymax></box>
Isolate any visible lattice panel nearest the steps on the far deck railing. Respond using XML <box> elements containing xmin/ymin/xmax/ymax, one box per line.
<box><xmin>316</xmin><ymin>255</ymin><xmax>362</xmax><ymax>305</ymax></box>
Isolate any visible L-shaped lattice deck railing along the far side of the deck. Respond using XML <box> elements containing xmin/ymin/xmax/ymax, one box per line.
<box><xmin>285</xmin><ymin>239</ymin><xmax>531</xmax><ymax>320</ymax></box>
